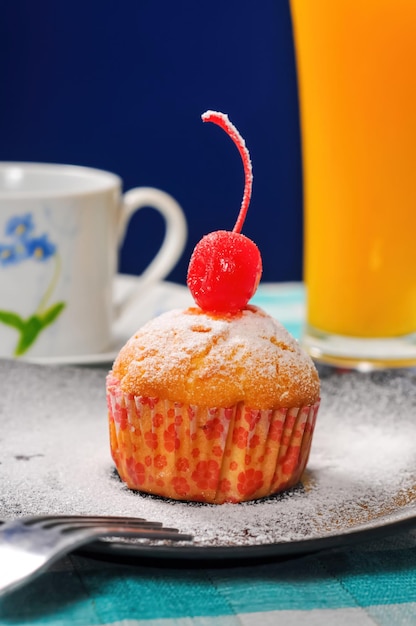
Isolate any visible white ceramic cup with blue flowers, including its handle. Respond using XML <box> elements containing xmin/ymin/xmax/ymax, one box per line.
<box><xmin>0</xmin><ymin>162</ymin><xmax>187</xmax><ymax>358</ymax></box>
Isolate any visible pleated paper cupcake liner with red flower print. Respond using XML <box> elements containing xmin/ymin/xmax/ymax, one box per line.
<box><xmin>107</xmin><ymin>374</ymin><xmax>319</xmax><ymax>504</ymax></box>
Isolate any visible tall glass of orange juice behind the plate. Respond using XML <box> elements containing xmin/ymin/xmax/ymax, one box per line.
<box><xmin>290</xmin><ymin>0</ymin><xmax>416</xmax><ymax>369</ymax></box>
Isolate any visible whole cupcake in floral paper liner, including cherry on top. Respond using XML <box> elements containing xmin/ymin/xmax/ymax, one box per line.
<box><xmin>107</xmin><ymin>112</ymin><xmax>320</xmax><ymax>504</ymax></box>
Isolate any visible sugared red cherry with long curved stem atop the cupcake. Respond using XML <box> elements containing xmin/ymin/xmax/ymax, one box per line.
<box><xmin>187</xmin><ymin>111</ymin><xmax>262</xmax><ymax>313</ymax></box>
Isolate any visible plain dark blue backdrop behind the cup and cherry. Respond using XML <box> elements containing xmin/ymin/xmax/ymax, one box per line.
<box><xmin>0</xmin><ymin>0</ymin><xmax>302</xmax><ymax>283</ymax></box>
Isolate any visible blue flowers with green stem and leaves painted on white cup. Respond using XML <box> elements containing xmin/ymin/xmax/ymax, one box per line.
<box><xmin>0</xmin><ymin>213</ymin><xmax>65</xmax><ymax>356</ymax></box>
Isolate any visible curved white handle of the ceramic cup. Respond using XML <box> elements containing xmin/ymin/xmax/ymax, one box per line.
<box><xmin>118</xmin><ymin>187</ymin><xmax>188</xmax><ymax>314</ymax></box>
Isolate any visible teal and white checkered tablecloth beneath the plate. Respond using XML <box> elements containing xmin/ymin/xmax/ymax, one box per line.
<box><xmin>0</xmin><ymin>284</ymin><xmax>416</xmax><ymax>626</ymax></box>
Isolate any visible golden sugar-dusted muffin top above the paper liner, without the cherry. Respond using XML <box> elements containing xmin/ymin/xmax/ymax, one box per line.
<box><xmin>112</xmin><ymin>306</ymin><xmax>320</xmax><ymax>409</ymax></box>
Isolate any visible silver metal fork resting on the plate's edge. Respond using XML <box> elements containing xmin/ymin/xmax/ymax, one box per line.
<box><xmin>0</xmin><ymin>515</ymin><xmax>193</xmax><ymax>596</ymax></box>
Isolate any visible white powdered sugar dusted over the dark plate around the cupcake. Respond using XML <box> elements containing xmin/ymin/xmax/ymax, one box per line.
<box><xmin>0</xmin><ymin>361</ymin><xmax>416</xmax><ymax>556</ymax></box>
